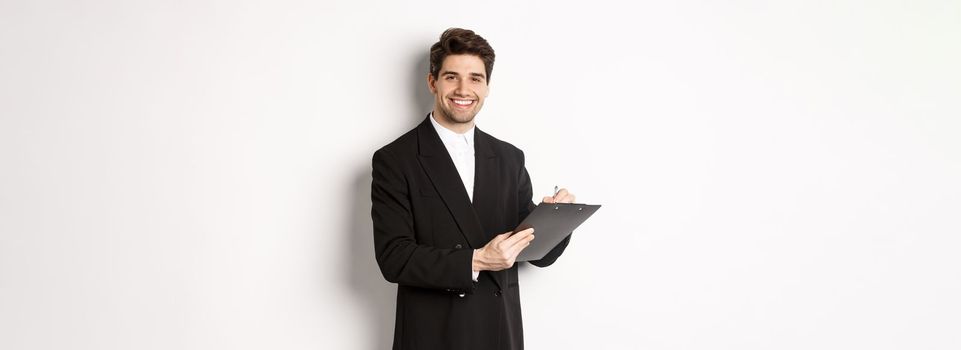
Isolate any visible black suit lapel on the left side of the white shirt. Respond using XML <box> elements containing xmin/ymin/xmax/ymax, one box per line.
<box><xmin>417</xmin><ymin>117</ymin><xmax>489</xmax><ymax>249</ymax></box>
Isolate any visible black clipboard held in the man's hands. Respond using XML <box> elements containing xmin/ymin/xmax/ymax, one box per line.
<box><xmin>514</xmin><ymin>203</ymin><xmax>601</xmax><ymax>261</ymax></box>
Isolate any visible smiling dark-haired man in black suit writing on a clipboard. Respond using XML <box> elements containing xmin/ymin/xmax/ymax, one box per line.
<box><xmin>371</xmin><ymin>28</ymin><xmax>574</xmax><ymax>350</ymax></box>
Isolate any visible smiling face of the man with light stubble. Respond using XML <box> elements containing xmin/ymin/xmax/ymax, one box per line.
<box><xmin>427</xmin><ymin>55</ymin><xmax>488</xmax><ymax>125</ymax></box>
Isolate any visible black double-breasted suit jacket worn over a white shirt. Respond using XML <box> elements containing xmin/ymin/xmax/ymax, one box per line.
<box><xmin>371</xmin><ymin>117</ymin><xmax>570</xmax><ymax>350</ymax></box>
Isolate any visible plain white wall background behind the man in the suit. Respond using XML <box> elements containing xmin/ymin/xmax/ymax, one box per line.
<box><xmin>0</xmin><ymin>0</ymin><xmax>961</xmax><ymax>350</ymax></box>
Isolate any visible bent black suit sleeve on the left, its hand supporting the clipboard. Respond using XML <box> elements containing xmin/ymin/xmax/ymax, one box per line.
<box><xmin>370</xmin><ymin>150</ymin><xmax>474</xmax><ymax>293</ymax></box>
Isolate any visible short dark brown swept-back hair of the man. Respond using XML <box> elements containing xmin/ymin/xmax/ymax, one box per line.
<box><xmin>430</xmin><ymin>28</ymin><xmax>494</xmax><ymax>82</ymax></box>
